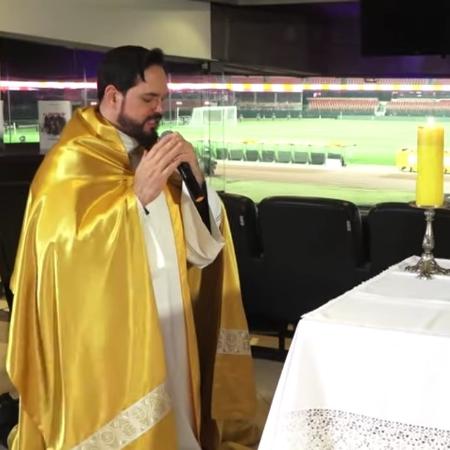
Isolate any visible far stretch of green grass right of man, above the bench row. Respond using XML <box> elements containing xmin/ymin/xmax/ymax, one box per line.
<box><xmin>163</xmin><ymin>117</ymin><xmax>450</xmax><ymax>165</ymax></box>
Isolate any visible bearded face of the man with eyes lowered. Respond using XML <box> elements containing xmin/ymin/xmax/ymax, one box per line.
<box><xmin>117</xmin><ymin>66</ymin><xmax>168</xmax><ymax>148</ymax></box>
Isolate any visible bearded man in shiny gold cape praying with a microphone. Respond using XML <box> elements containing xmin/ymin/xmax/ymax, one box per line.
<box><xmin>7</xmin><ymin>46</ymin><xmax>255</xmax><ymax>450</ymax></box>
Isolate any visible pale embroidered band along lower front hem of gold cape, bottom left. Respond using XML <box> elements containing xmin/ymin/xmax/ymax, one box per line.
<box><xmin>72</xmin><ymin>384</ymin><xmax>170</xmax><ymax>450</ymax></box>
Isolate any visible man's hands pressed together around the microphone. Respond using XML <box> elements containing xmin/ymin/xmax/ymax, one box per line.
<box><xmin>134</xmin><ymin>133</ymin><xmax>204</xmax><ymax>206</ymax></box>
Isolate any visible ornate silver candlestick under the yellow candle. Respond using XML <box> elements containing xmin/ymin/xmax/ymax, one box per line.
<box><xmin>405</xmin><ymin>205</ymin><xmax>450</xmax><ymax>279</ymax></box>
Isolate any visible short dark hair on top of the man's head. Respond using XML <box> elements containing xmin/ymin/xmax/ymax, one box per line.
<box><xmin>97</xmin><ymin>45</ymin><xmax>164</xmax><ymax>101</ymax></box>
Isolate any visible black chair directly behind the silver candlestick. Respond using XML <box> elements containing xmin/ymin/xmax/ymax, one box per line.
<box><xmin>367</xmin><ymin>202</ymin><xmax>450</xmax><ymax>275</ymax></box>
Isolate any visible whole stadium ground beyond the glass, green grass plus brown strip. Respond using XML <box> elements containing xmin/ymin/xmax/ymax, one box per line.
<box><xmin>5</xmin><ymin>116</ymin><xmax>450</xmax><ymax>205</ymax></box>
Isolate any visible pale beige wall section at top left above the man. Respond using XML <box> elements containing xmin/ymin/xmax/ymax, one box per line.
<box><xmin>0</xmin><ymin>0</ymin><xmax>211</xmax><ymax>59</ymax></box>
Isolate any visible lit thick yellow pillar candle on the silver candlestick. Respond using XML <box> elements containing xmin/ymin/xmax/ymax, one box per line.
<box><xmin>416</xmin><ymin>125</ymin><xmax>444</xmax><ymax>207</ymax></box>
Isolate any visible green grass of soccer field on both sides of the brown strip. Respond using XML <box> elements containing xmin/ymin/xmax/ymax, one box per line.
<box><xmin>5</xmin><ymin>117</ymin><xmax>450</xmax><ymax>205</ymax></box>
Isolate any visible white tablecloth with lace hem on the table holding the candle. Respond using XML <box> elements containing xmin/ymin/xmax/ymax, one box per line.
<box><xmin>259</xmin><ymin>259</ymin><xmax>450</xmax><ymax>450</ymax></box>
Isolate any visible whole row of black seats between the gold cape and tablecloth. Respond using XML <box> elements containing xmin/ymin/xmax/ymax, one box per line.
<box><xmin>220</xmin><ymin>192</ymin><xmax>450</xmax><ymax>353</ymax></box>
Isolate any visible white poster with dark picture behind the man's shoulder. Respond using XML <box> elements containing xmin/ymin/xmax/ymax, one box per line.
<box><xmin>38</xmin><ymin>100</ymin><xmax>72</xmax><ymax>153</ymax></box>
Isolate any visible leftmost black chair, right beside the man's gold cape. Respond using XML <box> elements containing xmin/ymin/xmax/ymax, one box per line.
<box><xmin>219</xmin><ymin>192</ymin><xmax>285</xmax><ymax>357</ymax></box>
